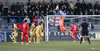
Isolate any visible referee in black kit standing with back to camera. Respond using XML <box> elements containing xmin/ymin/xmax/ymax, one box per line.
<box><xmin>80</xmin><ymin>19</ymin><xmax>90</xmax><ymax>44</ymax></box>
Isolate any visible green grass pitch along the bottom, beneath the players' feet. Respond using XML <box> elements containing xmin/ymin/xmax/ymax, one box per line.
<box><xmin>0</xmin><ymin>41</ymin><xmax>100</xmax><ymax>51</ymax></box>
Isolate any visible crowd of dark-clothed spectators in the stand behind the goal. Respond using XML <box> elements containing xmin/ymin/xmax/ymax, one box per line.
<box><xmin>0</xmin><ymin>0</ymin><xmax>100</xmax><ymax>22</ymax></box>
